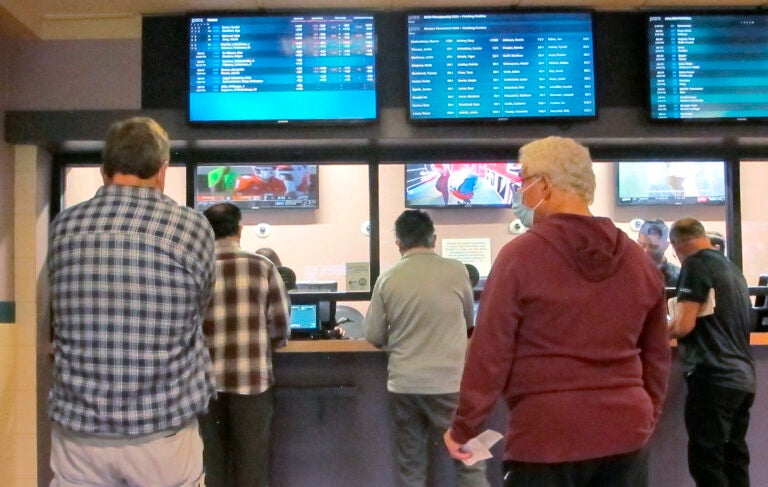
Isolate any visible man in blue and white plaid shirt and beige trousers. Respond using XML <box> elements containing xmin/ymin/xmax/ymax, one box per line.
<box><xmin>48</xmin><ymin>117</ymin><xmax>216</xmax><ymax>487</ymax></box>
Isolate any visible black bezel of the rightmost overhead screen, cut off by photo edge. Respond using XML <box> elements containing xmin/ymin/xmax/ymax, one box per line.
<box><xmin>644</xmin><ymin>9</ymin><xmax>768</xmax><ymax>125</ymax></box>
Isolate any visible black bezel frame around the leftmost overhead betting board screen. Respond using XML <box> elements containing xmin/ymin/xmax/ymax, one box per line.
<box><xmin>184</xmin><ymin>9</ymin><xmax>381</xmax><ymax>127</ymax></box>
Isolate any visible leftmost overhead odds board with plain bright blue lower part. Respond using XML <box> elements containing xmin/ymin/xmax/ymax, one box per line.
<box><xmin>188</xmin><ymin>14</ymin><xmax>377</xmax><ymax>123</ymax></box>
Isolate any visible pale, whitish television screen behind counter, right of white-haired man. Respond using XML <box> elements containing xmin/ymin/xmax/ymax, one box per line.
<box><xmin>616</xmin><ymin>161</ymin><xmax>725</xmax><ymax>206</ymax></box>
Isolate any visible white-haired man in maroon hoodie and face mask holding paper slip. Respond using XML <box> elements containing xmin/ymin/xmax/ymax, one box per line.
<box><xmin>444</xmin><ymin>137</ymin><xmax>669</xmax><ymax>487</ymax></box>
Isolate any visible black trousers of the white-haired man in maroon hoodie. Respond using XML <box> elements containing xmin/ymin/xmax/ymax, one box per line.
<box><xmin>503</xmin><ymin>449</ymin><xmax>648</xmax><ymax>487</ymax></box>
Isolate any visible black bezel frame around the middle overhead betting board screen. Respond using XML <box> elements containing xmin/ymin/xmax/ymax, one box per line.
<box><xmin>402</xmin><ymin>8</ymin><xmax>600</xmax><ymax>125</ymax></box>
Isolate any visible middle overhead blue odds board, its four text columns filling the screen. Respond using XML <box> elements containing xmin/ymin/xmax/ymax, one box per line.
<box><xmin>408</xmin><ymin>11</ymin><xmax>597</xmax><ymax>121</ymax></box>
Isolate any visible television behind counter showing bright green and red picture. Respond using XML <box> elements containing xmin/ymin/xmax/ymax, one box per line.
<box><xmin>195</xmin><ymin>163</ymin><xmax>319</xmax><ymax>211</ymax></box>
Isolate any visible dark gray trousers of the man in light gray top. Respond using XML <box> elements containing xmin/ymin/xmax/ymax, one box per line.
<box><xmin>389</xmin><ymin>392</ymin><xmax>489</xmax><ymax>487</ymax></box>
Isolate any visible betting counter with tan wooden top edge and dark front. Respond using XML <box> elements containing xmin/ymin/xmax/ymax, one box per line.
<box><xmin>272</xmin><ymin>333</ymin><xmax>768</xmax><ymax>487</ymax></box>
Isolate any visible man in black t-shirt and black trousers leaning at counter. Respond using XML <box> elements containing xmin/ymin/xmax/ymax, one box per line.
<box><xmin>669</xmin><ymin>218</ymin><xmax>755</xmax><ymax>487</ymax></box>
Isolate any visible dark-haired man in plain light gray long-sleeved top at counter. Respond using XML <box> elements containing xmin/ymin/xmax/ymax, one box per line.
<box><xmin>363</xmin><ymin>210</ymin><xmax>489</xmax><ymax>487</ymax></box>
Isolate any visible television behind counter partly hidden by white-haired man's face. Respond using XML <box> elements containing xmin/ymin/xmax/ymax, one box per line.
<box><xmin>405</xmin><ymin>161</ymin><xmax>520</xmax><ymax>208</ymax></box>
